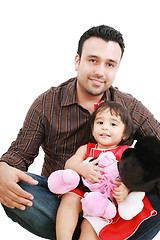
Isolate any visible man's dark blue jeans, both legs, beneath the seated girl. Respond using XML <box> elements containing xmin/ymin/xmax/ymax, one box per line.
<box><xmin>3</xmin><ymin>173</ymin><xmax>160</xmax><ymax>240</ymax></box>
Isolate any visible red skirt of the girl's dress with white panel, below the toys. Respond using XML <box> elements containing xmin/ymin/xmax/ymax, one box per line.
<box><xmin>71</xmin><ymin>188</ymin><xmax>157</xmax><ymax>240</ymax></box>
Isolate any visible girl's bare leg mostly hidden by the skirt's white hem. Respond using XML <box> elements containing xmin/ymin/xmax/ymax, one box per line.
<box><xmin>79</xmin><ymin>219</ymin><xmax>99</xmax><ymax>240</ymax></box>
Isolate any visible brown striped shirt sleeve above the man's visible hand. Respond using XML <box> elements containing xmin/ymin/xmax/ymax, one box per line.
<box><xmin>0</xmin><ymin>94</ymin><xmax>44</xmax><ymax>171</ymax></box>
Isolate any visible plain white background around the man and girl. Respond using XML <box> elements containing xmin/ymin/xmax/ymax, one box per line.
<box><xmin>0</xmin><ymin>0</ymin><xmax>160</xmax><ymax>240</ymax></box>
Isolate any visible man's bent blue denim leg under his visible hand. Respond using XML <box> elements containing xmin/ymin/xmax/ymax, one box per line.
<box><xmin>3</xmin><ymin>174</ymin><xmax>60</xmax><ymax>239</ymax></box>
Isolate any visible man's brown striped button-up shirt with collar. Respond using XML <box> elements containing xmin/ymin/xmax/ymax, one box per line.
<box><xmin>0</xmin><ymin>78</ymin><xmax>160</xmax><ymax>177</ymax></box>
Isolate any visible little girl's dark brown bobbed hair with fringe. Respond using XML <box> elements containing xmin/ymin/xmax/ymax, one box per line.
<box><xmin>91</xmin><ymin>101</ymin><xmax>133</xmax><ymax>145</ymax></box>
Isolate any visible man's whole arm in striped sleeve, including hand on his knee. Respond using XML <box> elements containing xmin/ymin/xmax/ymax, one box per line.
<box><xmin>0</xmin><ymin>95</ymin><xmax>44</xmax><ymax>210</ymax></box>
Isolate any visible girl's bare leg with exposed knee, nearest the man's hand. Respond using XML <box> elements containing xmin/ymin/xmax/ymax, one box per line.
<box><xmin>56</xmin><ymin>192</ymin><xmax>82</xmax><ymax>240</ymax></box>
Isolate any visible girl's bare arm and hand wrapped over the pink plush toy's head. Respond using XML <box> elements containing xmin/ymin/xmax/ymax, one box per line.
<box><xmin>65</xmin><ymin>145</ymin><xmax>104</xmax><ymax>182</ymax></box>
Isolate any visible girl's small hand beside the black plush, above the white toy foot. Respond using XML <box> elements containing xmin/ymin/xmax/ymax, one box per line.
<box><xmin>112</xmin><ymin>181</ymin><xmax>130</xmax><ymax>202</ymax></box>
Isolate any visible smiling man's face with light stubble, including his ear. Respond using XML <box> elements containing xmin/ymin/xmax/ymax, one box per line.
<box><xmin>75</xmin><ymin>37</ymin><xmax>122</xmax><ymax>96</ymax></box>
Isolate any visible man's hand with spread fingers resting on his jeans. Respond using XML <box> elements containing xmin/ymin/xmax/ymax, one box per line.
<box><xmin>0</xmin><ymin>162</ymin><xmax>38</xmax><ymax>210</ymax></box>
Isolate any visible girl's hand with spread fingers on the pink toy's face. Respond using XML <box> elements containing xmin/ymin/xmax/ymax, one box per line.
<box><xmin>81</xmin><ymin>158</ymin><xmax>105</xmax><ymax>183</ymax></box>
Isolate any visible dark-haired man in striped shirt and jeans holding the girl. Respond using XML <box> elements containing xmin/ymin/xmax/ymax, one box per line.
<box><xmin>0</xmin><ymin>25</ymin><xmax>160</xmax><ymax>240</ymax></box>
